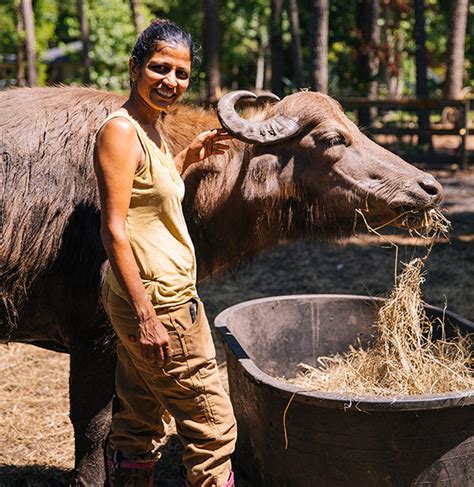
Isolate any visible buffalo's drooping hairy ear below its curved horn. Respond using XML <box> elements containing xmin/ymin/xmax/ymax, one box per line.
<box><xmin>242</xmin><ymin>154</ymin><xmax>279</xmax><ymax>201</ymax></box>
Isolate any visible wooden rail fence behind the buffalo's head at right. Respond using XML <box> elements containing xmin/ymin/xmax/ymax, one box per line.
<box><xmin>339</xmin><ymin>98</ymin><xmax>470</xmax><ymax>169</ymax></box>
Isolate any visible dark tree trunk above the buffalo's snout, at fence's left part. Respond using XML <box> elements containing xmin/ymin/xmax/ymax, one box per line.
<box><xmin>356</xmin><ymin>0</ymin><xmax>380</xmax><ymax>126</ymax></box>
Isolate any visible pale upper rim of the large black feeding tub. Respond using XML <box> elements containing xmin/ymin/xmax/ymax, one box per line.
<box><xmin>214</xmin><ymin>294</ymin><xmax>474</xmax><ymax>411</ymax></box>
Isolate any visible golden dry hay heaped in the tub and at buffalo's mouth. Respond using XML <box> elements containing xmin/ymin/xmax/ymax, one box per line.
<box><xmin>291</xmin><ymin>209</ymin><xmax>474</xmax><ymax>396</ymax></box>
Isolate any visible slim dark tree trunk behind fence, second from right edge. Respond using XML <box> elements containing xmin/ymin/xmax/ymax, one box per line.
<box><xmin>414</xmin><ymin>0</ymin><xmax>431</xmax><ymax>144</ymax></box>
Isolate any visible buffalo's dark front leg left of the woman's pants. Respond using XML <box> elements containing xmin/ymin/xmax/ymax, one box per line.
<box><xmin>69</xmin><ymin>340</ymin><xmax>115</xmax><ymax>486</ymax></box>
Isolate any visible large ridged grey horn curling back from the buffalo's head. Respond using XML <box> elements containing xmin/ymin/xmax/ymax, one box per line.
<box><xmin>217</xmin><ymin>91</ymin><xmax>301</xmax><ymax>145</ymax></box>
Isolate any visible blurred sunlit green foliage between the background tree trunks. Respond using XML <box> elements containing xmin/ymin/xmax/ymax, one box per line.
<box><xmin>0</xmin><ymin>0</ymin><xmax>474</xmax><ymax>96</ymax></box>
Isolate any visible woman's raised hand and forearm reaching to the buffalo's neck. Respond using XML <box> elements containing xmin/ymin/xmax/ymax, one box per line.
<box><xmin>174</xmin><ymin>129</ymin><xmax>233</xmax><ymax>173</ymax></box>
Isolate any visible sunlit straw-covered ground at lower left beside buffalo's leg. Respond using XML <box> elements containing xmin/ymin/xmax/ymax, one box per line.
<box><xmin>0</xmin><ymin>343</ymin><xmax>74</xmax><ymax>472</ymax></box>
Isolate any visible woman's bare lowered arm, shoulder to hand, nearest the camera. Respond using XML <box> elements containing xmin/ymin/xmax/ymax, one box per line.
<box><xmin>94</xmin><ymin>118</ymin><xmax>172</xmax><ymax>364</ymax></box>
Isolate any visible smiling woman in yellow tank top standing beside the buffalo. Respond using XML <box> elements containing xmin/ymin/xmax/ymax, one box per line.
<box><xmin>94</xmin><ymin>20</ymin><xmax>236</xmax><ymax>487</ymax></box>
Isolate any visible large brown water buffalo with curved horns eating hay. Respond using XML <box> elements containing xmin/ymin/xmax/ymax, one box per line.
<box><xmin>0</xmin><ymin>87</ymin><xmax>441</xmax><ymax>485</ymax></box>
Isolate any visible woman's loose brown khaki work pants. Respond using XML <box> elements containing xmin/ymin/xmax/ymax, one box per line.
<box><xmin>103</xmin><ymin>284</ymin><xmax>236</xmax><ymax>487</ymax></box>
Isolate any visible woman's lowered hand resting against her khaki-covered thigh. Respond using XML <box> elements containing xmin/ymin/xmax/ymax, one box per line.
<box><xmin>138</xmin><ymin>308</ymin><xmax>173</xmax><ymax>367</ymax></box>
